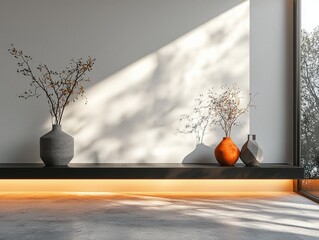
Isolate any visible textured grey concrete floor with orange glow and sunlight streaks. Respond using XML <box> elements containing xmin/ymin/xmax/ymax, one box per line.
<box><xmin>0</xmin><ymin>193</ymin><xmax>319</xmax><ymax>240</ymax></box>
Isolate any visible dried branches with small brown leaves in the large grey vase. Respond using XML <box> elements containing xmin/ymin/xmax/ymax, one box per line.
<box><xmin>8</xmin><ymin>44</ymin><xmax>95</xmax><ymax>124</ymax></box>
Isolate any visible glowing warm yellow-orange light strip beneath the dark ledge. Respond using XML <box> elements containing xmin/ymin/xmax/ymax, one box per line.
<box><xmin>0</xmin><ymin>179</ymin><xmax>293</xmax><ymax>194</ymax></box>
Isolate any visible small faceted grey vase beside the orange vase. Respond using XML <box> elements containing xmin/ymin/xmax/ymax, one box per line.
<box><xmin>240</xmin><ymin>134</ymin><xmax>263</xmax><ymax>167</ymax></box>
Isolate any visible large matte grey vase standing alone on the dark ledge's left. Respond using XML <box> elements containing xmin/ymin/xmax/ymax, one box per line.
<box><xmin>40</xmin><ymin>125</ymin><xmax>74</xmax><ymax>166</ymax></box>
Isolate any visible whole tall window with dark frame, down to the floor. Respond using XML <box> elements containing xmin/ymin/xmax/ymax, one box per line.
<box><xmin>295</xmin><ymin>0</ymin><xmax>319</xmax><ymax>200</ymax></box>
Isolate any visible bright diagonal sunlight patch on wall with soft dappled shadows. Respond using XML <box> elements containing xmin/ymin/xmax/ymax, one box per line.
<box><xmin>64</xmin><ymin>1</ymin><xmax>249</xmax><ymax>163</ymax></box>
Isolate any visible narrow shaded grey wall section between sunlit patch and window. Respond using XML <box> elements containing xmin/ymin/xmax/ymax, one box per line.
<box><xmin>250</xmin><ymin>0</ymin><xmax>293</xmax><ymax>163</ymax></box>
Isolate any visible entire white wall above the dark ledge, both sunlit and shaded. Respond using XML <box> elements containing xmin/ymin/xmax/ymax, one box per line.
<box><xmin>0</xmin><ymin>0</ymin><xmax>292</xmax><ymax>162</ymax></box>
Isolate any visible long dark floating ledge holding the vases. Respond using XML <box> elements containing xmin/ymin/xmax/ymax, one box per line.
<box><xmin>0</xmin><ymin>163</ymin><xmax>304</xmax><ymax>179</ymax></box>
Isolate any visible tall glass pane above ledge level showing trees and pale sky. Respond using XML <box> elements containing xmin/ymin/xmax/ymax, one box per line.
<box><xmin>300</xmin><ymin>0</ymin><xmax>319</xmax><ymax>178</ymax></box>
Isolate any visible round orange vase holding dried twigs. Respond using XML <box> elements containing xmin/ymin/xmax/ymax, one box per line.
<box><xmin>214</xmin><ymin>137</ymin><xmax>240</xmax><ymax>166</ymax></box>
